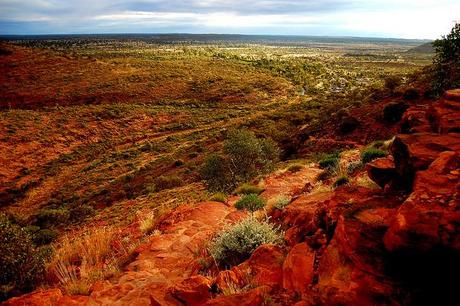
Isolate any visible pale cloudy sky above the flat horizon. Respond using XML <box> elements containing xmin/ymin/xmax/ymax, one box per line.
<box><xmin>0</xmin><ymin>0</ymin><xmax>460</xmax><ymax>39</ymax></box>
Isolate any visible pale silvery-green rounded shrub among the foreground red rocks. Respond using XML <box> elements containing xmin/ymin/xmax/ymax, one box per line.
<box><xmin>209</xmin><ymin>217</ymin><xmax>282</xmax><ymax>268</ymax></box>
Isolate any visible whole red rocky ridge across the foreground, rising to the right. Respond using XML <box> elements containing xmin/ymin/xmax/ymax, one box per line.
<box><xmin>4</xmin><ymin>90</ymin><xmax>460</xmax><ymax>306</ymax></box>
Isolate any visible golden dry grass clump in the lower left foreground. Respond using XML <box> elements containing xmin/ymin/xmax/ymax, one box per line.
<box><xmin>48</xmin><ymin>227</ymin><xmax>137</xmax><ymax>295</ymax></box>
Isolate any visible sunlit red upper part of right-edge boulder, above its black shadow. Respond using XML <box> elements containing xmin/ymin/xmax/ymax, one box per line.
<box><xmin>385</xmin><ymin>152</ymin><xmax>460</xmax><ymax>253</ymax></box>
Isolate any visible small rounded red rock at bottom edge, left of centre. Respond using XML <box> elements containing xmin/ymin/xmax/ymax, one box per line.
<box><xmin>172</xmin><ymin>275</ymin><xmax>211</xmax><ymax>305</ymax></box>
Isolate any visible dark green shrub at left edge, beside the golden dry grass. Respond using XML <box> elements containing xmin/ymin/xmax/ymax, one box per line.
<box><xmin>0</xmin><ymin>214</ymin><xmax>45</xmax><ymax>301</ymax></box>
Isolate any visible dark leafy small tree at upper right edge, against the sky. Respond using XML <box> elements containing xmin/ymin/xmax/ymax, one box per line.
<box><xmin>433</xmin><ymin>23</ymin><xmax>460</xmax><ymax>93</ymax></box>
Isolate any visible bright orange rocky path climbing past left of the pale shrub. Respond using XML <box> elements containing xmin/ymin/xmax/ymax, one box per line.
<box><xmin>88</xmin><ymin>167</ymin><xmax>321</xmax><ymax>305</ymax></box>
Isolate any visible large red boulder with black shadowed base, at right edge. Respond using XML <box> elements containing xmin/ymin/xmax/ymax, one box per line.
<box><xmin>384</xmin><ymin>152</ymin><xmax>460</xmax><ymax>305</ymax></box>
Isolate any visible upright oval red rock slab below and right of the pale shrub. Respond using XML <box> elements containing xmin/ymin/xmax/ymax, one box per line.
<box><xmin>283</xmin><ymin>242</ymin><xmax>315</xmax><ymax>293</ymax></box>
